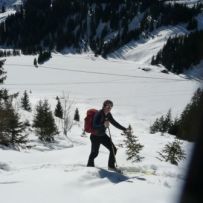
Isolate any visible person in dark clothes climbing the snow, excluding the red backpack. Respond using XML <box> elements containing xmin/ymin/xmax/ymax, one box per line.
<box><xmin>87</xmin><ymin>100</ymin><xmax>127</xmax><ymax>172</ymax></box>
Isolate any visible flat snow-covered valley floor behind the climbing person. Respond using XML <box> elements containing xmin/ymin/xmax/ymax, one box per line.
<box><xmin>2</xmin><ymin>52</ymin><xmax>197</xmax><ymax>126</ymax></box>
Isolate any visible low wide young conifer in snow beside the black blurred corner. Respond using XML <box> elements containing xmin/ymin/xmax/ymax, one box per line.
<box><xmin>158</xmin><ymin>138</ymin><xmax>185</xmax><ymax>165</ymax></box>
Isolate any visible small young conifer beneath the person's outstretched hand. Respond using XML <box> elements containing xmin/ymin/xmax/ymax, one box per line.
<box><xmin>124</xmin><ymin>125</ymin><xmax>144</xmax><ymax>162</ymax></box>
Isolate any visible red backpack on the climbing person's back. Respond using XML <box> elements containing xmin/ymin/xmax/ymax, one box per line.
<box><xmin>84</xmin><ymin>109</ymin><xmax>98</xmax><ymax>135</ymax></box>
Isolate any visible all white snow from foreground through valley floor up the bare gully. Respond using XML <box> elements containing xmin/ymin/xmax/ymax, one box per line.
<box><xmin>0</xmin><ymin>27</ymin><xmax>200</xmax><ymax>203</ymax></box>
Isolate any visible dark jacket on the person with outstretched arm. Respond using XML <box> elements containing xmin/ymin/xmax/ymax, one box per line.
<box><xmin>93</xmin><ymin>110</ymin><xmax>126</xmax><ymax>135</ymax></box>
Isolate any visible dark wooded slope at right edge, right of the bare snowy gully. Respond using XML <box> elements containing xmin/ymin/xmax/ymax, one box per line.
<box><xmin>151</xmin><ymin>31</ymin><xmax>203</xmax><ymax>73</ymax></box>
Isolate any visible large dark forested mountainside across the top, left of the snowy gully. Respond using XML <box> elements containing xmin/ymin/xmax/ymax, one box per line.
<box><xmin>0</xmin><ymin>0</ymin><xmax>201</xmax><ymax>57</ymax></box>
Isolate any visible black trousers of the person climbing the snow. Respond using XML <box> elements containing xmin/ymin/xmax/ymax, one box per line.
<box><xmin>87</xmin><ymin>134</ymin><xmax>117</xmax><ymax>168</ymax></box>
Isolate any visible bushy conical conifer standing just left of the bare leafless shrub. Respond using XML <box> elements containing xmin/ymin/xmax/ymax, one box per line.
<box><xmin>33</xmin><ymin>100</ymin><xmax>58</xmax><ymax>142</ymax></box>
